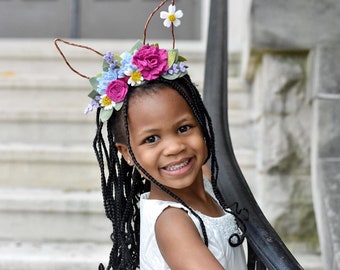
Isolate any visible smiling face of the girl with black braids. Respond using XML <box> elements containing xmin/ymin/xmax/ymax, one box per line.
<box><xmin>121</xmin><ymin>87</ymin><xmax>207</xmax><ymax>192</ymax></box>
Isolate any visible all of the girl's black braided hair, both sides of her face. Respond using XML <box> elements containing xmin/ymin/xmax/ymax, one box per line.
<box><xmin>93</xmin><ymin>75</ymin><xmax>245</xmax><ymax>270</ymax></box>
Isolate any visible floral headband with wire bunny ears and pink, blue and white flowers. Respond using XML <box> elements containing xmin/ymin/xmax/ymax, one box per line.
<box><xmin>54</xmin><ymin>0</ymin><xmax>187</xmax><ymax>122</ymax></box>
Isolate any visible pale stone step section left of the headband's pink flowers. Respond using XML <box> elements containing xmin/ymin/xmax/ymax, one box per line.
<box><xmin>0</xmin><ymin>73</ymin><xmax>91</xmax><ymax>109</ymax></box>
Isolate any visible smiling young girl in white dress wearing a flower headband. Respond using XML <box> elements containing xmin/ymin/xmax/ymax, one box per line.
<box><xmin>56</xmin><ymin>1</ymin><xmax>246</xmax><ymax>270</ymax></box>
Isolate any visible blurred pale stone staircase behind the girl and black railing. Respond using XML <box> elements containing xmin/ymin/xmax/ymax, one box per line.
<box><xmin>0</xmin><ymin>40</ymin><xmax>321</xmax><ymax>270</ymax></box>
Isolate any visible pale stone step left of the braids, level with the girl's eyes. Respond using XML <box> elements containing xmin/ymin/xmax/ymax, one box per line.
<box><xmin>0</xmin><ymin>111</ymin><xmax>96</xmax><ymax>146</ymax></box>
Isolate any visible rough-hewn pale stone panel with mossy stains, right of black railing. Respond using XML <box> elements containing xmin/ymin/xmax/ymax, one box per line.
<box><xmin>252</xmin><ymin>53</ymin><xmax>317</xmax><ymax>249</ymax></box>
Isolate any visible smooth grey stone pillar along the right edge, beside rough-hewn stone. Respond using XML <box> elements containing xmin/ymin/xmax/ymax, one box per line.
<box><xmin>308</xmin><ymin>43</ymin><xmax>340</xmax><ymax>270</ymax></box>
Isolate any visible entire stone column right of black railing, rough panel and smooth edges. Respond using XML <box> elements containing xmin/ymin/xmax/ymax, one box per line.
<box><xmin>242</xmin><ymin>0</ymin><xmax>340</xmax><ymax>264</ymax></box>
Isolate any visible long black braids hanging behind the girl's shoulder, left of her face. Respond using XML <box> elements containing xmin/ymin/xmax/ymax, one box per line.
<box><xmin>93</xmin><ymin>106</ymin><xmax>150</xmax><ymax>270</ymax></box>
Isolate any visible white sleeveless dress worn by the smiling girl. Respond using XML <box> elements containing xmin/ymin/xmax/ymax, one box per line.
<box><xmin>140</xmin><ymin>180</ymin><xmax>247</xmax><ymax>270</ymax></box>
